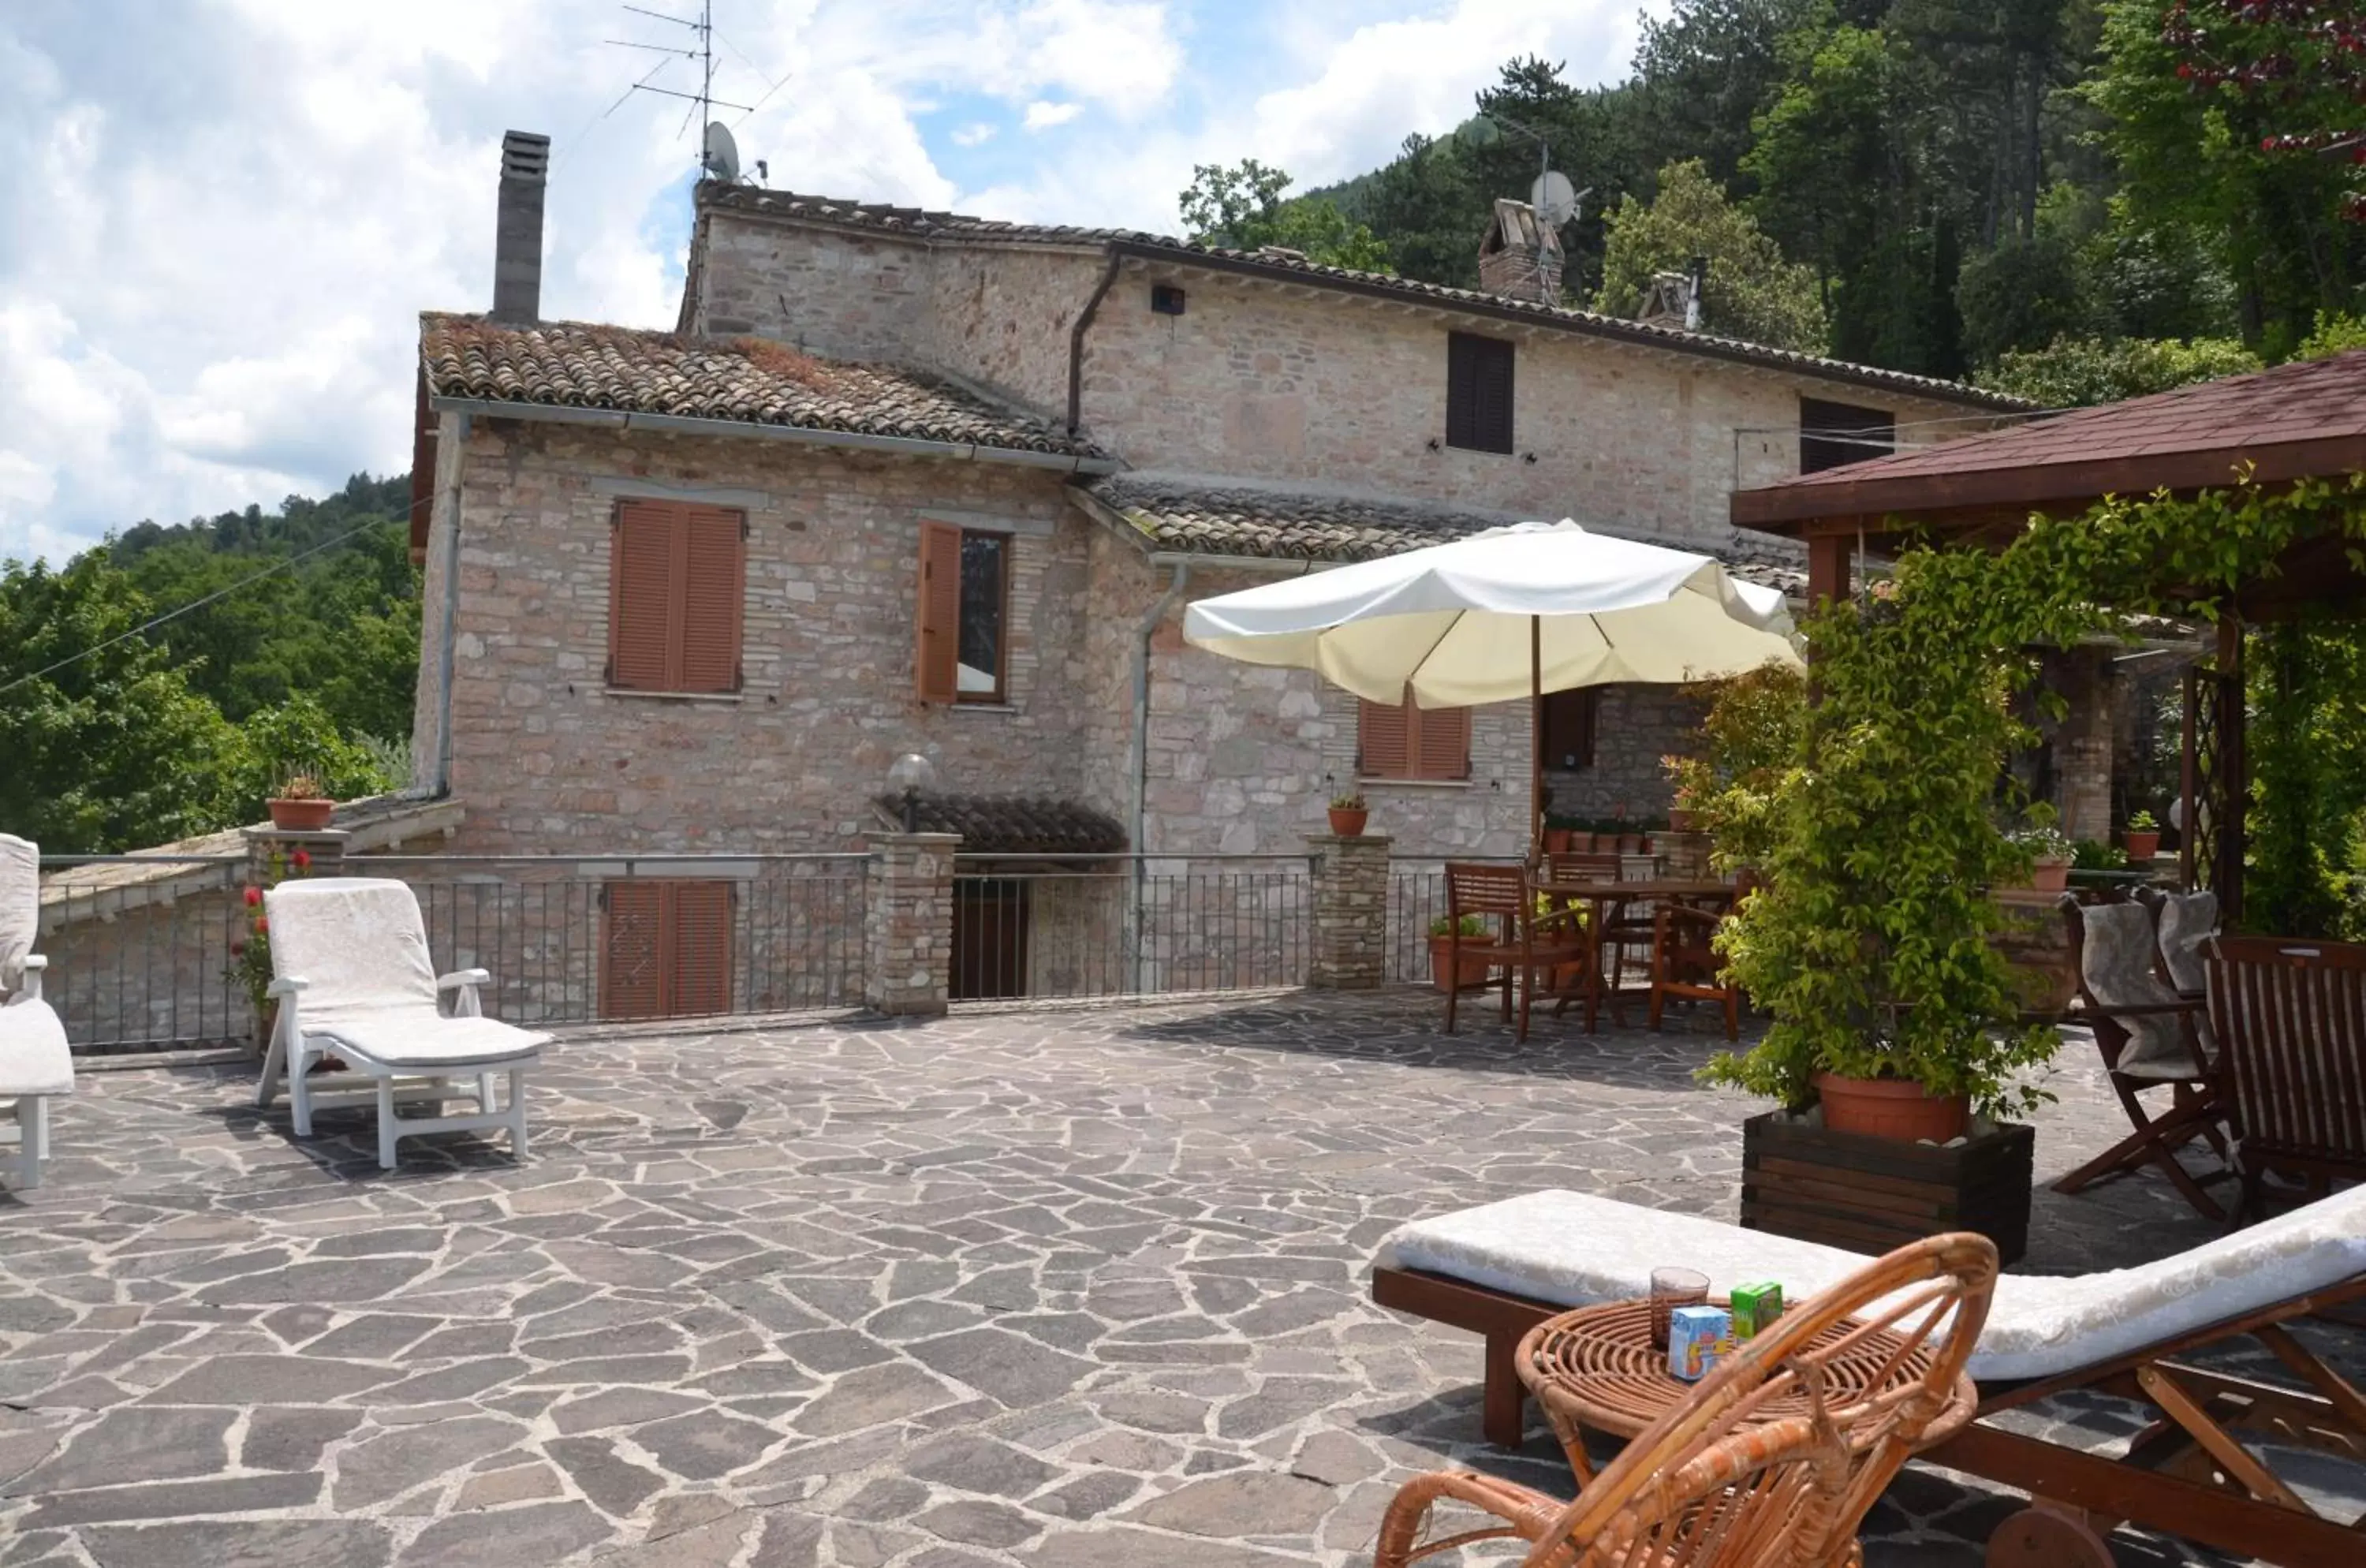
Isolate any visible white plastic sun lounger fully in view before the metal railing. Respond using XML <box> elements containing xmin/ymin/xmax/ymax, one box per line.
<box><xmin>256</xmin><ymin>877</ymin><xmax>551</xmax><ymax>1170</ymax></box>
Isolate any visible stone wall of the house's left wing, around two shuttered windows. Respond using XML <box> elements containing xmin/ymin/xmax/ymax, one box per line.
<box><xmin>416</xmin><ymin>421</ymin><xmax>1093</xmax><ymax>853</ymax></box>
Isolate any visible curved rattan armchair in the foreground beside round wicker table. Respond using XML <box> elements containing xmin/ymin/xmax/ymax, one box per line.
<box><xmin>1372</xmin><ymin>1232</ymin><xmax>1997</xmax><ymax>1568</ymax></box>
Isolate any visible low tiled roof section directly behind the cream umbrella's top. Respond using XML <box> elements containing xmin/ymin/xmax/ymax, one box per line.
<box><xmin>1079</xmin><ymin>473</ymin><xmax>1808</xmax><ymax>594</ymax></box>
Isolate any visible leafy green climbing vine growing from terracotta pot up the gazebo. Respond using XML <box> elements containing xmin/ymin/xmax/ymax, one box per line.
<box><xmin>1704</xmin><ymin>478</ymin><xmax>2366</xmax><ymax>1114</ymax></box>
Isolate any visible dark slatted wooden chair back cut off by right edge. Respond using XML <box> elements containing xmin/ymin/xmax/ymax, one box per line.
<box><xmin>2203</xmin><ymin>936</ymin><xmax>2366</xmax><ymax>1220</ymax></box>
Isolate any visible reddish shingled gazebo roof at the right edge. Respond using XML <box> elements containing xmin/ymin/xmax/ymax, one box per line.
<box><xmin>1732</xmin><ymin>350</ymin><xmax>2366</xmax><ymax>532</ymax></box>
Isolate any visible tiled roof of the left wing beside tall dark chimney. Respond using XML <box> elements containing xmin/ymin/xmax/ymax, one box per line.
<box><xmin>419</xmin><ymin>312</ymin><xmax>1100</xmax><ymax>459</ymax></box>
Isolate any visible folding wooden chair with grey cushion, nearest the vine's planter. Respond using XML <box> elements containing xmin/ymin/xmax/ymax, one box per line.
<box><xmin>2054</xmin><ymin>898</ymin><xmax>2234</xmax><ymax>1220</ymax></box>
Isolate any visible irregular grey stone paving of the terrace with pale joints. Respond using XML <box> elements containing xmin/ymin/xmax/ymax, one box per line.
<box><xmin>0</xmin><ymin>993</ymin><xmax>2347</xmax><ymax>1568</ymax></box>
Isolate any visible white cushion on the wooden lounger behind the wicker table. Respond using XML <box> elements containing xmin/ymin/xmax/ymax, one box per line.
<box><xmin>1379</xmin><ymin>1187</ymin><xmax>2366</xmax><ymax>1381</ymax></box>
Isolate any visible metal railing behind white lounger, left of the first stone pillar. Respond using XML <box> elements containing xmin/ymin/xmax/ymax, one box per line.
<box><xmin>40</xmin><ymin>853</ymin><xmax>868</xmax><ymax>1055</ymax></box>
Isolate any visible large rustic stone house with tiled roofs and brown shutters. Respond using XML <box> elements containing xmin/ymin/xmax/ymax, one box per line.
<box><xmin>397</xmin><ymin>137</ymin><xmax>2018</xmax><ymax>1007</ymax></box>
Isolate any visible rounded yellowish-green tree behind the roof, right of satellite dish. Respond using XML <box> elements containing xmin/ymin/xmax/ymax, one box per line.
<box><xmin>1595</xmin><ymin>159</ymin><xmax>1827</xmax><ymax>355</ymax></box>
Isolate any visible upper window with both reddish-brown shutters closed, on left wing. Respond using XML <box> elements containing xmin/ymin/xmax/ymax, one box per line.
<box><xmin>608</xmin><ymin>502</ymin><xmax>748</xmax><ymax>691</ymax></box>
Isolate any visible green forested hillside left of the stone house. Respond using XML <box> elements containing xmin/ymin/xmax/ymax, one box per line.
<box><xmin>0</xmin><ymin>476</ymin><xmax>419</xmax><ymax>853</ymax></box>
